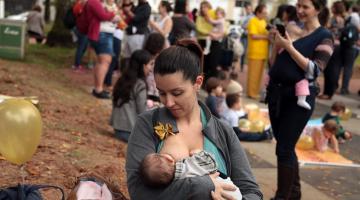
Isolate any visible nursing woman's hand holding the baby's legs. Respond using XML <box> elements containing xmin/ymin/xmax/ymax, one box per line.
<box><xmin>209</xmin><ymin>172</ymin><xmax>236</xmax><ymax>200</ymax></box>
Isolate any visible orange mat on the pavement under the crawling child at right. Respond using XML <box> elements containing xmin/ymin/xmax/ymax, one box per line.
<box><xmin>296</xmin><ymin>149</ymin><xmax>353</xmax><ymax>164</ymax></box>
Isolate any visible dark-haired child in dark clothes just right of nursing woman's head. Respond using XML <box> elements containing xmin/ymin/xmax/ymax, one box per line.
<box><xmin>205</xmin><ymin>77</ymin><xmax>224</xmax><ymax>118</ymax></box>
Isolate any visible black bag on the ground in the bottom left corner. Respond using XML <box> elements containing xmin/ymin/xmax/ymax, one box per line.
<box><xmin>0</xmin><ymin>184</ymin><xmax>65</xmax><ymax>200</ymax></box>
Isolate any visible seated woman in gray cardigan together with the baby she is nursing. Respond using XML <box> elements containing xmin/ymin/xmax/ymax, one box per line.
<box><xmin>126</xmin><ymin>40</ymin><xmax>262</xmax><ymax>200</ymax></box>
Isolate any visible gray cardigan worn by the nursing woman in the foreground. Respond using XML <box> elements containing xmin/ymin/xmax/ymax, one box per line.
<box><xmin>126</xmin><ymin>102</ymin><xmax>263</xmax><ymax>200</ymax></box>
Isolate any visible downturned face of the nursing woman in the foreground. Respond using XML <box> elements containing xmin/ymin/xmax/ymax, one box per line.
<box><xmin>155</xmin><ymin>72</ymin><xmax>203</xmax><ymax>118</ymax></box>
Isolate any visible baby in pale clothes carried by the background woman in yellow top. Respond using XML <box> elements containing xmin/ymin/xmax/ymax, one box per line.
<box><xmin>204</xmin><ymin>7</ymin><xmax>225</xmax><ymax>55</ymax></box>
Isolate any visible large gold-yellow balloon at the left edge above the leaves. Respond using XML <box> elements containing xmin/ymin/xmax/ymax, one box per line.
<box><xmin>0</xmin><ymin>99</ymin><xmax>42</xmax><ymax>165</ymax></box>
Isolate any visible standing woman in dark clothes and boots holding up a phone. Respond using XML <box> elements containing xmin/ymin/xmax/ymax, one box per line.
<box><xmin>266</xmin><ymin>0</ymin><xmax>334</xmax><ymax>200</ymax></box>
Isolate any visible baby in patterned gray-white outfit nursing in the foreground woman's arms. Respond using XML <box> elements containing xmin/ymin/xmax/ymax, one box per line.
<box><xmin>140</xmin><ymin>150</ymin><xmax>242</xmax><ymax>199</ymax></box>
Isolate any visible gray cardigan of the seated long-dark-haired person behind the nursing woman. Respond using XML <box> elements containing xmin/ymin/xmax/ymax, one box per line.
<box><xmin>110</xmin><ymin>79</ymin><xmax>147</xmax><ymax>132</ymax></box>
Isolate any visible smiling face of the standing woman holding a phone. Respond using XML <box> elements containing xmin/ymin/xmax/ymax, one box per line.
<box><xmin>296</xmin><ymin>0</ymin><xmax>319</xmax><ymax>22</ymax></box>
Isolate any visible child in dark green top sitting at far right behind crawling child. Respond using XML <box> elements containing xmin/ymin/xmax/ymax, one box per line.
<box><xmin>322</xmin><ymin>101</ymin><xmax>352</xmax><ymax>143</ymax></box>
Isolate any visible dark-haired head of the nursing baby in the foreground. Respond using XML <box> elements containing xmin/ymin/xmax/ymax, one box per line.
<box><xmin>140</xmin><ymin>153</ymin><xmax>175</xmax><ymax>187</ymax></box>
